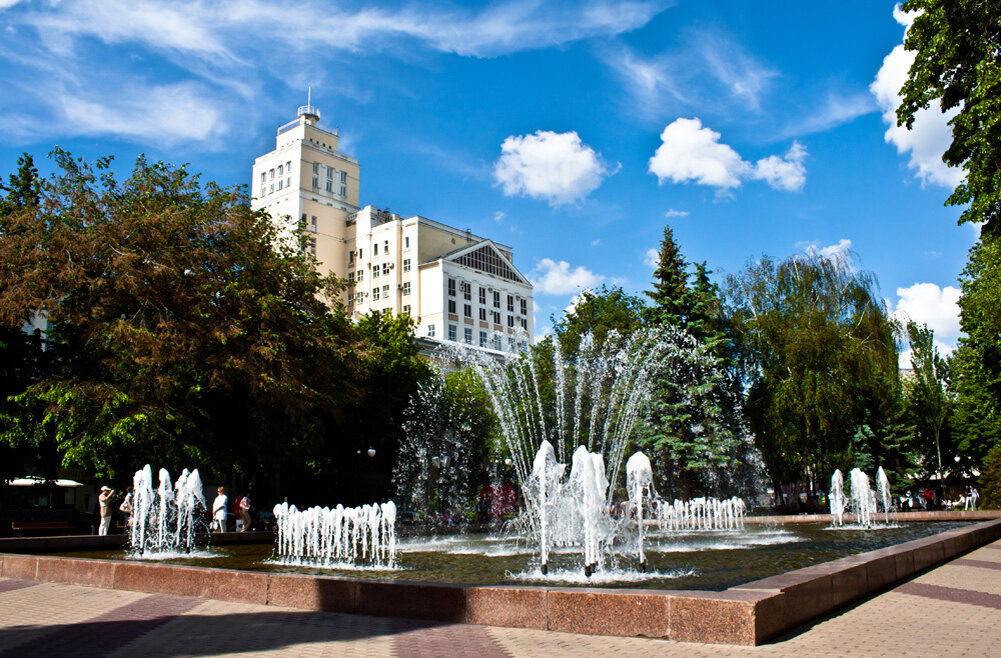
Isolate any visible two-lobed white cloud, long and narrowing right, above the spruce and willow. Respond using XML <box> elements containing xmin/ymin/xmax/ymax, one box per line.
<box><xmin>650</xmin><ymin>117</ymin><xmax>807</xmax><ymax>191</ymax></box>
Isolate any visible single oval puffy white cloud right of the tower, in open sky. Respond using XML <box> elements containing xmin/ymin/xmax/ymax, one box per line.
<box><xmin>493</xmin><ymin>130</ymin><xmax>615</xmax><ymax>205</ymax></box>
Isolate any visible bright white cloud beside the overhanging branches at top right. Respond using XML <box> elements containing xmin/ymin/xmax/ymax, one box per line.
<box><xmin>869</xmin><ymin>5</ymin><xmax>964</xmax><ymax>187</ymax></box>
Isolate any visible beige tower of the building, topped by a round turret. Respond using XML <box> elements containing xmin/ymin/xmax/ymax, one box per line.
<box><xmin>251</xmin><ymin>101</ymin><xmax>359</xmax><ymax>276</ymax></box>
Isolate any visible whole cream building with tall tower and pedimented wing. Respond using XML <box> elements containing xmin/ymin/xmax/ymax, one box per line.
<box><xmin>252</xmin><ymin>105</ymin><xmax>535</xmax><ymax>352</ymax></box>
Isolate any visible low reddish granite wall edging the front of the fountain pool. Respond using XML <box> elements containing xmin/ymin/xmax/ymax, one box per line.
<box><xmin>0</xmin><ymin>517</ymin><xmax>1001</xmax><ymax>645</ymax></box>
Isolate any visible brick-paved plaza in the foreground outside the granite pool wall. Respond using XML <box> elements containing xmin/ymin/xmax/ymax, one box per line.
<box><xmin>0</xmin><ymin>541</ymin><xmax>1001</xmax><ymax>658</ymax></box>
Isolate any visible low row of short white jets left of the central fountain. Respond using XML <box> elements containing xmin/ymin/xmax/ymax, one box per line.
<box><xmin>273</xmin><ymin>501</ymin><xmax>396</xmax><ymax>569</ymax></box>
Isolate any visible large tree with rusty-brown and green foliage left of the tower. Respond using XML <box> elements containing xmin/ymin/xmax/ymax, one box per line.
<box><xmin>0</xmin><ymin>149</ymin><xmax>359</xmax><ymax>477</ymax></box>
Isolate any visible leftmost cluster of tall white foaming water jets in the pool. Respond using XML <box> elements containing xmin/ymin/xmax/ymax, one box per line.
<box><xmin>128</xmin><ymin>464</ymin><xmax>205</xmax><ymax>558</ymax></box>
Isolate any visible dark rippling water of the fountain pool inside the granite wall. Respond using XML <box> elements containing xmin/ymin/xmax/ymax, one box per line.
<box><xmin>39</xmin><ymin>522</ymin><xmax>968</xmax><ymax>591</ymax></box>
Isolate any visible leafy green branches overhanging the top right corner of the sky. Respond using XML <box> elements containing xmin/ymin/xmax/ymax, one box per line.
<box><xmin>897</xmin><ymin>0</ymin><xmax>1001</xmax><ymax>237</ymax></box>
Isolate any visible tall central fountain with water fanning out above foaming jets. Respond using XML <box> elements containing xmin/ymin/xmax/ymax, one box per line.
<box><xmin>476</xmin><ymin>331</ymin><xmax>743</xmax><ymax>576</ymax></box>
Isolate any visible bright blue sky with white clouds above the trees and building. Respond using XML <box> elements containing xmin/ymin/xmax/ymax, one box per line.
<box><xmin>0</xmin><ymin>0</ymin><xmax>976</xmax><ymax>358</ymax></box>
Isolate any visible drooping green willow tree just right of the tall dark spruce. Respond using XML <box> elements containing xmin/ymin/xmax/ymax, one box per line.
<box><xmin>729</xmin><ymin>254</ymin><xmax>899</xmax><ymax>491</ymax></box>
